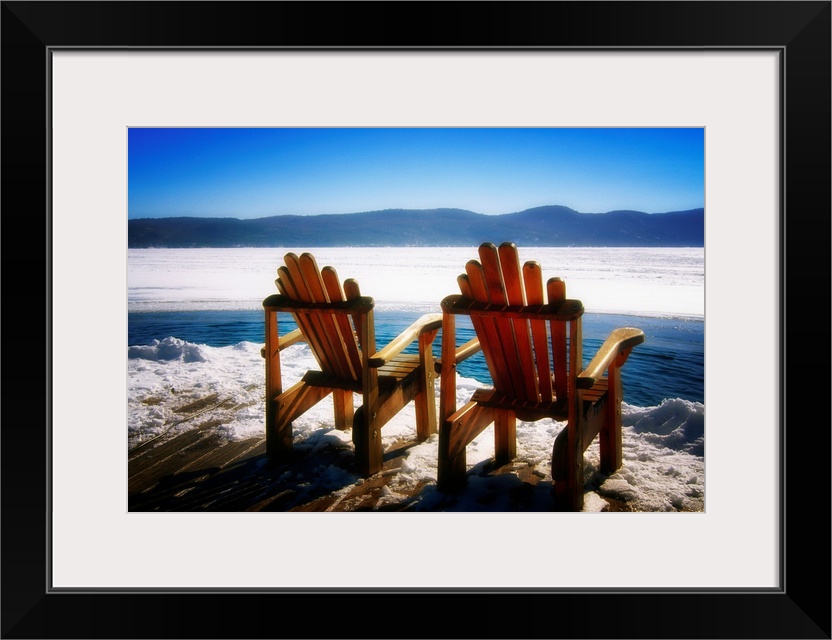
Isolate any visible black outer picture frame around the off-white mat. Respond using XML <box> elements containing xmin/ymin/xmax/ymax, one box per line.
<box><xmin>0</xmin><ymin>1</ymin><xmax>832</xmax><ymax>638</ymax></box>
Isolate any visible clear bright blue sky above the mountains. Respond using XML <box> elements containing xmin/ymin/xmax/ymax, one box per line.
<box><xmin>128</xmin><ymin>128</ymin><xmax>705</xmax><ymax>218</ymax></box>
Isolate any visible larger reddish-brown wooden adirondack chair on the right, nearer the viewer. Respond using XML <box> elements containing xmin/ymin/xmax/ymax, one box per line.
<box><xmin>438</xmin><ymin>243</ymin><xmax>644</xmax><ymax>511</ymax></box>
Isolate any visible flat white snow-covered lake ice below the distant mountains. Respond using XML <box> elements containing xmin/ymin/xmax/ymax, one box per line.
<box><xmin>127</xmin><ymin>247</ymin><xmax>705</xmax><ymax>318</ymax></box>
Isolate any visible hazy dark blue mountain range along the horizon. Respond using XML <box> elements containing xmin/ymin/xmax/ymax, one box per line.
<box><xmin>127</xmin><ymin>205</ymin><xmax>705</xmax><ymax>248</ymax></box>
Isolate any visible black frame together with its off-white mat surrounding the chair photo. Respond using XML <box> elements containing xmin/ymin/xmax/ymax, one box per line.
<box><xmin>0</xmin><ymin>2</ymin><xmax>830</xmax><ymax>638</ymax></box>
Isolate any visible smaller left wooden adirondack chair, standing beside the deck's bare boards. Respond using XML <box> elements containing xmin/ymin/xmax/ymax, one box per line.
<box><xmin>263</xmin><ymin>253</ymin><xmax>442</xmax><ymax>475</ymax></box>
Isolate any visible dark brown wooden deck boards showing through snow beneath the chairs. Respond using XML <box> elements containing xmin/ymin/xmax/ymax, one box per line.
<box><xmin>128</xmin><ymin>422</ymin><xmax>604</xmax><ymax>512</ymax></box>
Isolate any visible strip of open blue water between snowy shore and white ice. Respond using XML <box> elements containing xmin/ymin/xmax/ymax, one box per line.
<box><xmin>127</xmin><ymin>310</ymin><xmax>705</xmax><ymax>407</ymax></box>
